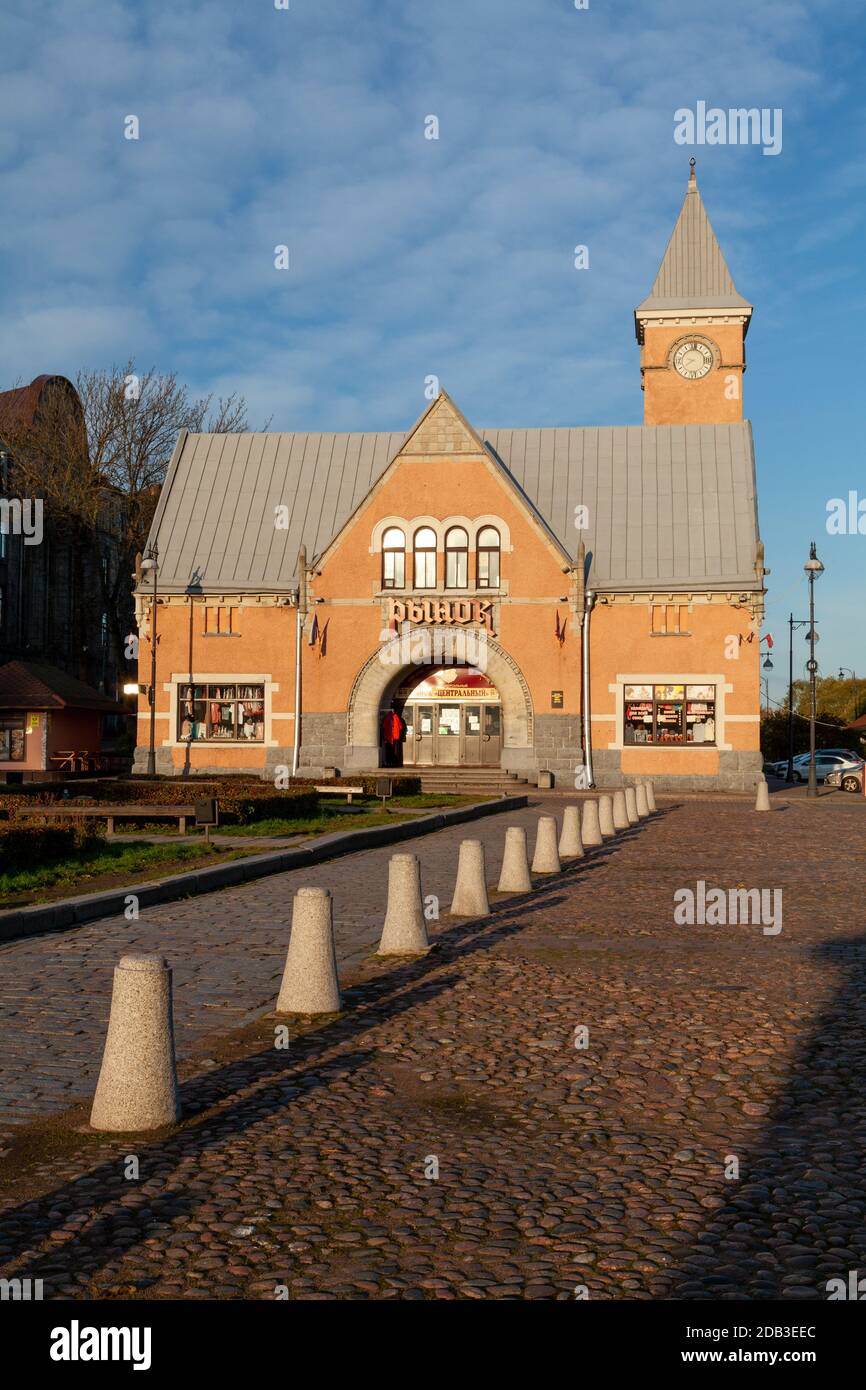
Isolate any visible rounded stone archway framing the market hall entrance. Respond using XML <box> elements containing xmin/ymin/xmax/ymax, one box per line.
<box><xmin>343</xmin><ymin>628</ymin><xmax>535</xmax><ymax>771</ymax></box>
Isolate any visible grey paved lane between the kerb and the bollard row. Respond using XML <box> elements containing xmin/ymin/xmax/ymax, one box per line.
<box><xmin>0</xmin><ymin>810</ymin><xmax>538</xmax><ymax>1133</ymax></box>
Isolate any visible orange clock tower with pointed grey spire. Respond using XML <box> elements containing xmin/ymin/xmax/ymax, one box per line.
<box><xmin>634</xmin><ymin>158</ymin><xmax>752</xmax><ymax>425</ymax></box>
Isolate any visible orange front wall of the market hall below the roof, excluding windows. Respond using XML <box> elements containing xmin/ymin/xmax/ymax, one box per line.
<box><xmin>136</xmin><ymin>449</ymin><xmax>760</xmax><ymax>787</ymax></box>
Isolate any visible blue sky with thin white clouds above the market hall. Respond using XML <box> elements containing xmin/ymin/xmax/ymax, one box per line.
<box><xmin>0</xmin><ymin>0</ymin><xmax>866</xmax><ymax>698</ymax></box>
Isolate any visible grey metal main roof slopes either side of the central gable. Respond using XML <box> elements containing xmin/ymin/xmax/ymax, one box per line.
<box><xmin>150</xmin><ymin>421</ymin><xmax>760</xmax><ymax>592</ymax></box>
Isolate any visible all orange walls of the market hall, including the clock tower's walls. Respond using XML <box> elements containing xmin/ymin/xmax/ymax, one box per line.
<box><xmin>136</xmin><ymin>168</ymin><xmax>765</xmax><ymax>788</ymax></box>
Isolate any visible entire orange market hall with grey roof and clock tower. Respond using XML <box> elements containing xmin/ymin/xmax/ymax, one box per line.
<box><xmin>135</xmin><ymin>167</ymin><xmax>766</xmax><ymax>788</ymax></box>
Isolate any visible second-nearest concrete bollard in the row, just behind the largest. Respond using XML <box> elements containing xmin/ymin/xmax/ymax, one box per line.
<box><xmin>277</xmin><ymin>888</ymin><xmax>341</xmax><ymax>1013</ymax></box>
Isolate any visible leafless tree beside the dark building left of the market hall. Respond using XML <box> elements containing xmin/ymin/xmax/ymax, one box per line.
<box><xmin>8</xmin><ymin>361</ymin><xmax>257</xmax><ymax>683</ymax></box>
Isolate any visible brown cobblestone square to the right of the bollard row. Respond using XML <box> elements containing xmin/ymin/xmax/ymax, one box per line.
<box><xmin>0</xmin><ymin>802</ymin><xmax>866</xmax><ymax>1300</ymax></box>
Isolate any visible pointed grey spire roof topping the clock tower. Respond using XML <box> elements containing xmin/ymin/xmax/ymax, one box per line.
<box><xmin>635</xmin><ymin>160</ymin><xmax>752</xmax><ymax>314</ymax></box>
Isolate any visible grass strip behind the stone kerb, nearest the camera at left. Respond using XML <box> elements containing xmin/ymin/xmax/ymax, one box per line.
<box><xmin>0</xmin><ymin>840</ymin><xmax>246</xmax><ymax>908</ymax></box>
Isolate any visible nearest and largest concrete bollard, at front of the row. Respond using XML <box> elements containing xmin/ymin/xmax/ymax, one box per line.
<box><xmin>90</xmin><ymin>955</ymin><xmax>181</xmax><ymax>1134</ymax></box>
